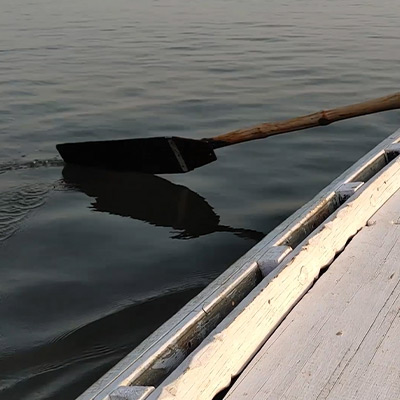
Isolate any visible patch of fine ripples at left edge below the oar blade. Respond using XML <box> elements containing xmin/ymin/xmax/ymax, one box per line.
<box><xmin>0</xmin><ymin>183</ymin><xmax>50</xmax><ymax>244</ymax></box>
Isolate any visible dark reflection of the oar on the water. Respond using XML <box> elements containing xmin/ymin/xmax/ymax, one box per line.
<box><xmin>63</xmin><ymin>165</ymin><xmax>264</xmax><ymax>241</ymax></box>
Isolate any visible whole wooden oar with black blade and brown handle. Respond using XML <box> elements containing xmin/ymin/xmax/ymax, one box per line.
<box><xmin>57</xmin><ymin>92</ymin><xmax>400</xmax><ymax>174</ymax></box>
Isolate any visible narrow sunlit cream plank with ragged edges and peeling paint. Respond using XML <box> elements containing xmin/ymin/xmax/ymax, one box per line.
<box><xmin>149</xmin><ymin>152</ymin><xmax>400</xmax><ymax>400</ymax></box>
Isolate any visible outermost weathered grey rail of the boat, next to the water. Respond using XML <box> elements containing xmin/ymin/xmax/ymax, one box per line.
<box><xmin>79</xmin><ymin>129</ymin><xmax>400</xmax><ymax>400</ymax></box>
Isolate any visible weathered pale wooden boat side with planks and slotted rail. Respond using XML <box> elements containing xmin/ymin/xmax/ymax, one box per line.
<box><xmin>79</xmin><ymin>129</ymin><xmax>400</xmax><ymax>400</ymax></box>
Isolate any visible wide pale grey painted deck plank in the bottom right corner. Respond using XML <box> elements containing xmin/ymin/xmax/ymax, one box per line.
<box><xmin>225</xmin><ymin>188</ymin><xmax>400</xmax><ymax>400</ymax></box>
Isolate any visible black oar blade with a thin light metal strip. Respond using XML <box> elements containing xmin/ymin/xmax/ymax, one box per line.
<box><xmin>56</xmin><ymin>137</ymin><xmax>217</xmax><ymax>174</ymax></box>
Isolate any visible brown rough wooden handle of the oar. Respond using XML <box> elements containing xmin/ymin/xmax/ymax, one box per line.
<box><xmin>206</xmin><ymin>92</ymin><xmax>400</xmax><ymax>148</ymax></box>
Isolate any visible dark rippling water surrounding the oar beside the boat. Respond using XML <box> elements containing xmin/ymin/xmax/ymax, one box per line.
<box><xmin>0</xmin><ymin>0</ymin><xmax>400</xmax><ymax>399</ymax></box>
